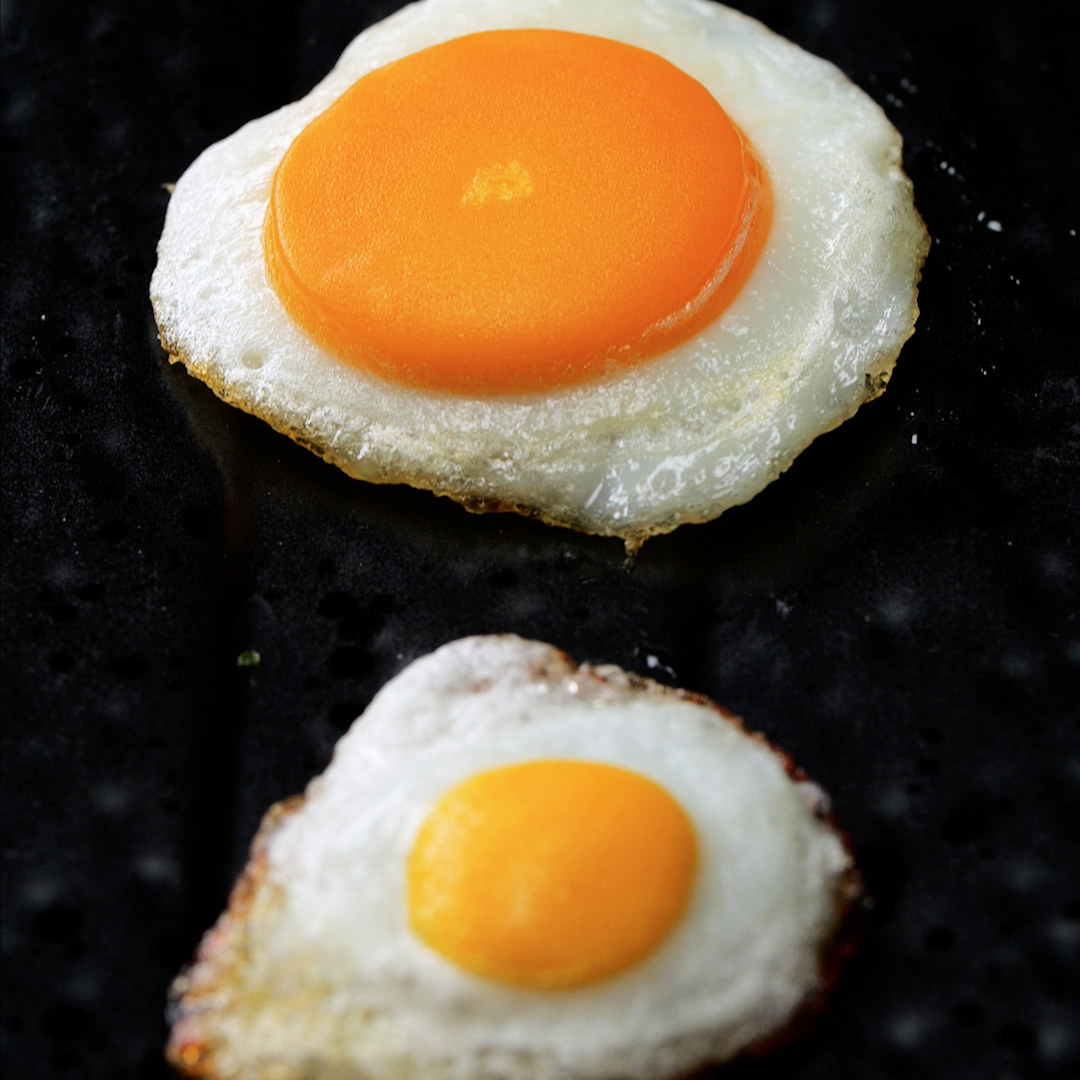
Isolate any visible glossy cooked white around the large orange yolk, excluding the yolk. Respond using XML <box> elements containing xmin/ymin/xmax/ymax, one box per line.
<box><xmin>150</xmin><ymin>0</ymin><xmax>928</xmax><ymax>546</ymax></box>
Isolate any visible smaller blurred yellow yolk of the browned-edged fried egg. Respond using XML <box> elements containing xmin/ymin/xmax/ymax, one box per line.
<box><xmin>408</xmin><ymin>760</ymin><xmax>697</xmax><ymax>990</ymax></box>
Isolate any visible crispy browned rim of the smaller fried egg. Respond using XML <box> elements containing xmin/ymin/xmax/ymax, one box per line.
<box><xmin>165</xmin><ymin>650</ymin><xmax>867</xmax><ymax>1080</ymax></box>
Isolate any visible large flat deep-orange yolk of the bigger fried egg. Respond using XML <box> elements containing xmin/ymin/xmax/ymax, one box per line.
<box><xmin>264</xmin><ymin>30</ymin><xmax>772</xmax><ymax>394</ymax></box>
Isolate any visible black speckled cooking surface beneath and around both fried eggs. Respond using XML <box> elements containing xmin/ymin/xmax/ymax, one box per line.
<box><xmin>2</xmin><ymin>0</ymin><xmax>1080</xmax><ymax>1080</ymax></box>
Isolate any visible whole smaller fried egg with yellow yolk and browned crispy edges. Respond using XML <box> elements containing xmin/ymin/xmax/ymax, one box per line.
<box><xmin>168</xmin><ymin>636</ymin><xmax>861</xmax><ymax>1080</ymax></box>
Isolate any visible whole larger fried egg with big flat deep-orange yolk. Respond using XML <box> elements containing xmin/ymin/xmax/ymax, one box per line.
<box><xmin>151</xmin><ymin>0</ymin><xmax>928</xmax><ymax>545</ymax></box>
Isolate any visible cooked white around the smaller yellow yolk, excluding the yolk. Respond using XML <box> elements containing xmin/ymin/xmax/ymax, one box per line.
<box><xmin>170</xmin><ymin>635</ymin><xmax>861</xmax><ymax>1080</ymax></box>
